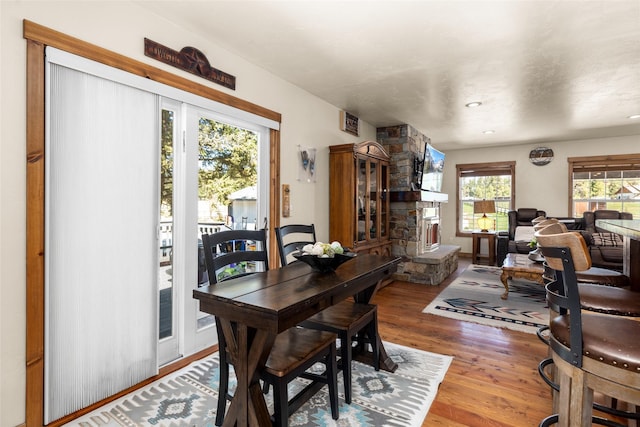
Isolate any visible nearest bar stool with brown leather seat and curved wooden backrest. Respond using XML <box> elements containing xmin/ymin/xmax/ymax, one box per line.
<box><xmin>536</xmin><ymin>232</ymin><xmax>640</xmax><ymax>426</ymax></box>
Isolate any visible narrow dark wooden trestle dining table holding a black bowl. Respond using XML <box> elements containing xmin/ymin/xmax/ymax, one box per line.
<box><xmin>193</xmin><ymin>254</ymin><xmax>400</xmax><ymax>426</ymax></box>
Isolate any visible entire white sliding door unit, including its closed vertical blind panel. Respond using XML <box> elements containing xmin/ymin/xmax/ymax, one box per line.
<box><xmin>40</xmin><ymin>48</ymin><xmax>279</xmax><ymax>423</ymax></box>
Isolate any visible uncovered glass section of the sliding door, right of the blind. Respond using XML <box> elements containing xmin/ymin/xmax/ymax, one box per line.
<box><xmin>158</xmin><ymin>100</ymin><xmax>269</xmax><ymax>365</ymax></box>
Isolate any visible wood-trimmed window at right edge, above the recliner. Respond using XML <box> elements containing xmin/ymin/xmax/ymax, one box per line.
<box><xmin>568</xmin><ymin>154</ymin><xmax>640</xmax><ymax>218</ymax></box>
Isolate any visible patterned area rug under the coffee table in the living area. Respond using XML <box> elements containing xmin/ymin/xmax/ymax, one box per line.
<box><xmin>422</xmin><ymin>264</ymin><xmax>549</xmax><ymax>333</ymax></box>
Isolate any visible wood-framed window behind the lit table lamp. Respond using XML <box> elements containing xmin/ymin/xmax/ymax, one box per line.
<box><xmin>456</xmin><ymin>162</ymin><xmax>516</xmax><ymax>235</ymax></box>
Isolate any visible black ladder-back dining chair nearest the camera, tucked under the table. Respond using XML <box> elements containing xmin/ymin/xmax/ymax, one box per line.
<box><xmin>202</xmin><ymin>229</ymin><xmax>339</xmax><ymax>426</ymax></box>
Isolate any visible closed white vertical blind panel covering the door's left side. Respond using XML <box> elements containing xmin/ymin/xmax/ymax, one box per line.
<box><xmin>45</xmin><ymin>64</ymin><xmax>159</xmax><ymax>423</ymax></box>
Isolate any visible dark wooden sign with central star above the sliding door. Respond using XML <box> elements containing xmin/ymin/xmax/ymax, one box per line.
<box><xmin>144</xmin><ymin>38</ymin><xmax>236</xmax><ymax>90</ymax></box>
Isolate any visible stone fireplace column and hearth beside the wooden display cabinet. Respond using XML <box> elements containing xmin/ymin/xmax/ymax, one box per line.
<box><xmin>376</xmin><ymin>124</ymin><xmax>460</xmax><ymax>285</ymax></box>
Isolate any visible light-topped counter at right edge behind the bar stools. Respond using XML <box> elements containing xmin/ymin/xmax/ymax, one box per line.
<box><xmin>596</xmin><ymin>219</ymin><xmax>640</xmax><ymax>291</ymax></box>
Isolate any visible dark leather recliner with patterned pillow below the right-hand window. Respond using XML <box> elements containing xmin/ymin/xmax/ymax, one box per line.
<box><xmin>581</xmin><ymin>209</ymin><xmax>633</xmax><ymax>271</ymax></box>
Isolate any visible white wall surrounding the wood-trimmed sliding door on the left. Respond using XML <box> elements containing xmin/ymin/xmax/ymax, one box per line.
<box><xmin>0</xmin><ymin>0</ymin><xmax>375</xmax><ymax>426</ymax></box>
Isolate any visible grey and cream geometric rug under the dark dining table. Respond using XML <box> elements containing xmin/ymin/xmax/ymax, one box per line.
<box><xmin>65</xmin><ymin>342</ymin><xmax>453</xmax><ymax>427</ymax></box>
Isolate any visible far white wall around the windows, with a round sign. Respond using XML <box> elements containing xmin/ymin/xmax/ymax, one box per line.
<box><xmin>440</xmin><ymin>135</ymin><xmax>640</xmax><ymax>253</ymax></box>
